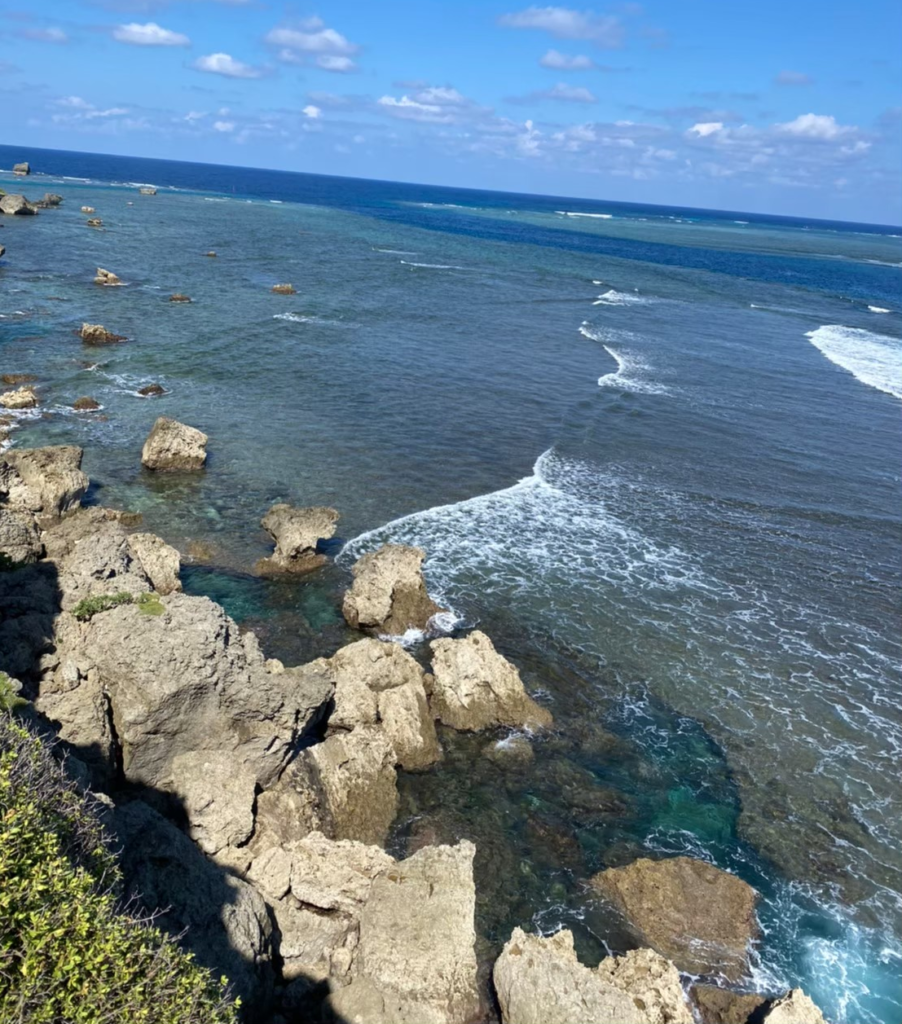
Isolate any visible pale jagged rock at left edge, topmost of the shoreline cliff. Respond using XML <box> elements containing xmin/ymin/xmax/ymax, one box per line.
<box><xmin>0</xmin><ymin>444</ymin><xmax>88</xmax><ymax>518</ymax></box>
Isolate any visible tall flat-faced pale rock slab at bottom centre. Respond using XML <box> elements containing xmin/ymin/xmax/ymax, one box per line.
<box><xmin>329</xmin><ymin>842</ymin><xmax>479</xmax><ymax>1024</ymax></box>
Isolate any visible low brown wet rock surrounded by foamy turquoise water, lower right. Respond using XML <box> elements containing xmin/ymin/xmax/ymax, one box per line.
<box><xmin>592</xmin><ymin>857</ymin><xmax>759</xmax><ymax>981</ymax></box>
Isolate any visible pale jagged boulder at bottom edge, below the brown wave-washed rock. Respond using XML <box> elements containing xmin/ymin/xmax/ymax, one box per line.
<box><xmin>492</xmin><ymin>928</ymin><xmax>692</xmax><ymax>1024</ymax></box>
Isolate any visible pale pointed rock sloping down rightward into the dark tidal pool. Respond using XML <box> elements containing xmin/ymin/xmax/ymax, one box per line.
<box><xmin>429</xmin><ymin>630</ymin><xmax>552</xmax><ymax>731</ymax></box>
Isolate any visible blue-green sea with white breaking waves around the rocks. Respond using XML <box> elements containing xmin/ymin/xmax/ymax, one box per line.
<box><xmin>0</xmin><ymin>146</ymin><xmax>902</xmax><ymax>1024</ymax></box>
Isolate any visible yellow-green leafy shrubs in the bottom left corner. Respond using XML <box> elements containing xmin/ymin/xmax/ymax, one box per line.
<box><xmin>0</xmin><ymin>712</ymin><xmax>237</xmax><ymax>1024</ymax></box>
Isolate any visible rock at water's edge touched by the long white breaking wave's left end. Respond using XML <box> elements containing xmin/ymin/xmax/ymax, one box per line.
<box><xmin>342</xmin><ymin>544</ymin><xmax>443</xmax><ymax>636</ymax></box>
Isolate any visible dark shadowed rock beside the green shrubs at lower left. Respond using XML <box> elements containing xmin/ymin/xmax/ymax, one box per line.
<box><xmin>112</xmin><ymin>801</ymin><xmax>273</xmax><ymax>1007</ymax></box>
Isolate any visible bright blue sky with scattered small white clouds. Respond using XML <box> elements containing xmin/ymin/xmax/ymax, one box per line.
<box><xmin>0</xmin><ymin>0</ymin><xmax>902</xmax><ymax>224</ymax></box>
